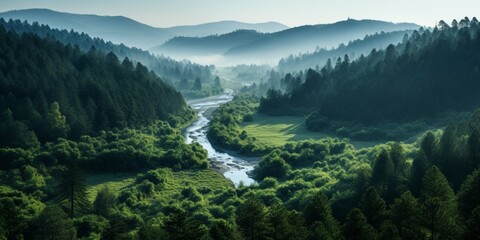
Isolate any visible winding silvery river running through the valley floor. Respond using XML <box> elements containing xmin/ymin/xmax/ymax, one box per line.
<box><xmin>185</xmin><ymin>89</ymin><xmax>258</xmax><ymax>186</ymax></box>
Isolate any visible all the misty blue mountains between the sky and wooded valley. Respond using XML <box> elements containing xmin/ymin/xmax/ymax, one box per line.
<box><xmin>0</xmin><ymin>9</ymin><xmax>420</xmax><ymax>65</ymax></box>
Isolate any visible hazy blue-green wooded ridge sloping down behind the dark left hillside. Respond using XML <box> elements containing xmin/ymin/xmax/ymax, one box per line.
<box><xmin>0</xmin><ymin>19</ymin><xmax>223</xmax><ymax>98</ymax></box>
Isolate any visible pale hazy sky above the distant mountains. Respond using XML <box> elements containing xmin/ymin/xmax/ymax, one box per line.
<box><xmin>0</xmin><ymin>0</ymin><xmax>480</xmax><ymax>27</ymax></box>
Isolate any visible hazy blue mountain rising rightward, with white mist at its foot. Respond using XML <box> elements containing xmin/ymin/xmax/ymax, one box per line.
<box><xmin>151</xmin><ymin>19</ymin><xmax>420</xmax><ymax>64</ymax></box>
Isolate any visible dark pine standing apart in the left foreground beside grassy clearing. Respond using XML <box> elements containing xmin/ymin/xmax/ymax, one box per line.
<box><xmin>57</xmin><ymin>161</ymin><xmax>90</xmax><ymax>218</ymax></box>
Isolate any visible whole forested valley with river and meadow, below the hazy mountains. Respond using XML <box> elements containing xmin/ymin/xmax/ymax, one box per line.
<box><xmin>0</xmin><ymin>2</ymin><xmax>480</xmax><ymax>240</ymax></box>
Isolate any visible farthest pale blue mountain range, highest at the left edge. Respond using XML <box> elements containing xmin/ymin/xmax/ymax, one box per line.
<box><xmin>0</xmin><ymin>9</ymin><xmax>288</xmax><ymax>49</ymax></box>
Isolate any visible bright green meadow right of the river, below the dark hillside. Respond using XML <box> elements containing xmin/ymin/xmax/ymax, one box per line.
<box><xmin>240</xmin><ymin>113</ymin><xmax>328</xmax><ymax>147</ymax></box>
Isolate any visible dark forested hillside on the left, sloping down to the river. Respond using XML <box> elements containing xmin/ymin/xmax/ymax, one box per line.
<box><xmin>0</xmin><ymin>27</ymin><xmax>192</xmax><ymax>147</ymax></box>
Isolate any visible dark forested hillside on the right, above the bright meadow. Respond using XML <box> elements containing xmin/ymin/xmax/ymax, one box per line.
<box><xmin>259</xmin><ymin>18</ymin><xmax>480</xmax><ymax>123</ymax></box>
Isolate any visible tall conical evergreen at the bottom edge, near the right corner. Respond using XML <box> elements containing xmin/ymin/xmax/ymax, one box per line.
<box><xmin>420</xmin><ymin>166</ymin><xmax>460</xmax><ymax>240</ymax></box>
